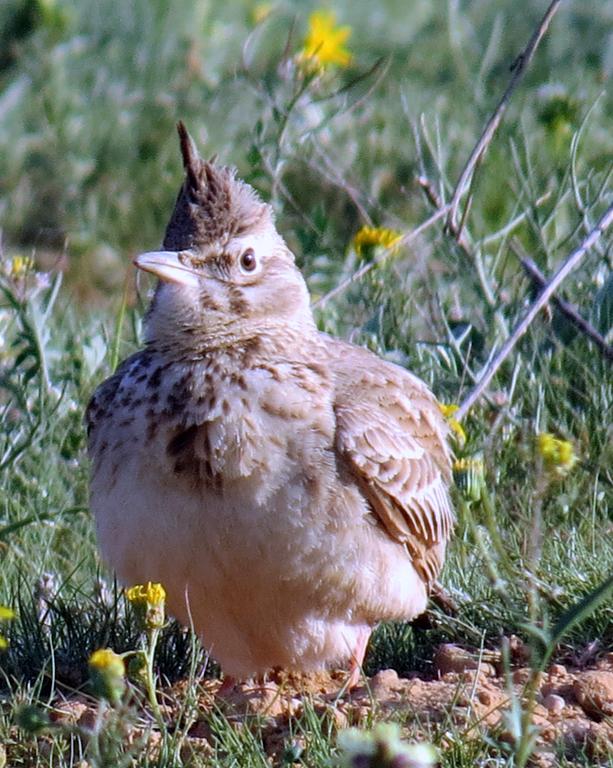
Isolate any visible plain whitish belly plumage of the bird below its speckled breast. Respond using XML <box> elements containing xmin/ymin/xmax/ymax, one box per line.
<box><xmin>91</xmin><ymin>364</ymin><xmax>426</xmax><ymax>677</ymax></box>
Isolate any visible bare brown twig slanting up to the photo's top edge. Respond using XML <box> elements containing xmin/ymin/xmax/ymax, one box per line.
<box><xmin>447</xmin><ymin>0</ymin><xmax>562</xmax><ymax>239</ymax></box>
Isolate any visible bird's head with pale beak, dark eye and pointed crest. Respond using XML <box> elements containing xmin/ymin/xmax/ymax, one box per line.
<box><xmin>134</xmin><ymin>123</ymin><xmax>313</xmax><ymax>349</ymax></box>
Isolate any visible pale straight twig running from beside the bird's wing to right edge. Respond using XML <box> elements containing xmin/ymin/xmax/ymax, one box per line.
<box><xmin>454</xmin><ymin>204</ymin><xmax>613</xmax><ymax>420</ymax></box>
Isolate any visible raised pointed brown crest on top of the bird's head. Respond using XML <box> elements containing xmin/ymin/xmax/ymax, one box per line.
<box><xmin>163</xmin><ymin>122</ymin><xmax>272</xmax><ymax>251</ymax></box>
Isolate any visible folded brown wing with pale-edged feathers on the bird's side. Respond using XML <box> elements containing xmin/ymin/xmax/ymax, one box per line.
<box><xmin>330</xmin><ymin>340</ymin><xmax>454</xmax><ymax>584</ymax></box>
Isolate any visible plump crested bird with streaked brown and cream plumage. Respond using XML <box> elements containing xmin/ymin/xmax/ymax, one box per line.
<box><xmin>86</xmin><ymin>122</ymin><xmax>454</xmax><ymax>686</ymax></box>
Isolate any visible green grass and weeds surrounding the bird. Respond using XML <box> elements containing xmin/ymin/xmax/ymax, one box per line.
<box><xmin>0</xmin><ymin>0</ymin><xmax>613</xmax><ymax>767</ymax></box>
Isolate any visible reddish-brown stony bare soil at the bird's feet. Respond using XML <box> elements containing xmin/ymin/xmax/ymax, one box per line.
<box><xmin>49</xmin><ymin>646</ymin><xmax>613</xmax><ymax>768</ymax></box>
